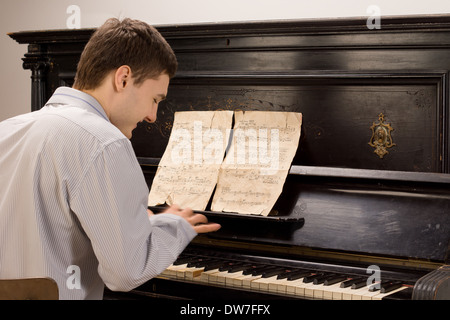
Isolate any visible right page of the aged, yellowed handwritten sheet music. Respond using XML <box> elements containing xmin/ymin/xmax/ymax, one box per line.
<box><xmin>211</xmin><ymin>111</ymin><xmax>302</xmax><ymax>216</ymax></box>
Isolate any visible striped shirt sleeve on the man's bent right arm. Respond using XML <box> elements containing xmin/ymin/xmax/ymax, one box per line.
<box><xmin>70</xmin><ymin>141</ymin><xmax>197</xmax><ymax>291</ymax></box>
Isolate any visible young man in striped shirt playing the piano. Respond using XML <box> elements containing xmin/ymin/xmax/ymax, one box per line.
<box><xmin>0</xmin><ymin>19</ymin><xmax>220</xmax><ymax>299</ymax></box>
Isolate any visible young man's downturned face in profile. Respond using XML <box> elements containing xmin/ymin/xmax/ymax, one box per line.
<box><xmin>110</xmin><ymin>73</ymin><xmax>170</xmax><ymax>139</ymax></box>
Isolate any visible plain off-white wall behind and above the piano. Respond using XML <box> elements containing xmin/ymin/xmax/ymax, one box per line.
<box><xmin>0</xmin><ymin>0</ymin><xmax>450</xmax><ymax>121</ymax></box>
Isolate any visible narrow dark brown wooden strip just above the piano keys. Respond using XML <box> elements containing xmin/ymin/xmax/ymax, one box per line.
<box><xmin>192</xmin><ymin>235</ymin><xmax>442</xmax><ymax>271</ymax></box>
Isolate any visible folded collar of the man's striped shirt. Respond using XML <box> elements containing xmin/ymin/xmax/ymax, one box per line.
<box><xmin>47</xmin><ymin>87</ymin><xmax>109</xmax><ymax>122</ymax></box>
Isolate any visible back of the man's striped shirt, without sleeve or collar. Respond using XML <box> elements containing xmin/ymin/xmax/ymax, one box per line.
<box><xmin>0</xmin><ymin>96</ymin><xmax>128</xmax><ymax>295</ymax></box>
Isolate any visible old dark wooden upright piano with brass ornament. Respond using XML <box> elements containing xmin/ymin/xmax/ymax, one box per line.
<box><xmin>10</xmin><ymin>15</ymin><xmax>450</xmax><ymax>300</ymax></box>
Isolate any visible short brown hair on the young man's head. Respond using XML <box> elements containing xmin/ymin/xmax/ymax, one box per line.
<box><xmin>73</xmin><ymin>18</ymin><xmax>178</xmax><ymax>90</ymax></box>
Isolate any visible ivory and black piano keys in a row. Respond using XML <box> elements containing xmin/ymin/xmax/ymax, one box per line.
<box><xmin>158</xmin><ymin>252</ymin><xmax>410</xmax><ymax>300</ymax></box>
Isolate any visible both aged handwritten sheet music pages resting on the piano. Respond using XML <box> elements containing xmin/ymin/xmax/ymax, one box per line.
<box><xmin>149</xmin><ymin>111</ymin><xmax>302</xmax><ymax>215</ymax></box>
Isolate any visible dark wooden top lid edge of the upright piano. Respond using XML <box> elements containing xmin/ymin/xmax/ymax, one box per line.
<box><xmin>8</xmin><ymin>14</ymin><xmax>450</xmax><ymax>44</ymax></box>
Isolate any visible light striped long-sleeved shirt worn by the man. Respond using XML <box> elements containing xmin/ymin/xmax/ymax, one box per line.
<box><xmin>0</xmin><ymin>87</ymin><xmax>196</xmax><ymax>299</ymax></box>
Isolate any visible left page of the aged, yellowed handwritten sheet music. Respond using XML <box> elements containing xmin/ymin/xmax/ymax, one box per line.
<box><xmin>148</xmin><ymin>111</ymin><xmax>233</xmax><ymax>210</ymax></box>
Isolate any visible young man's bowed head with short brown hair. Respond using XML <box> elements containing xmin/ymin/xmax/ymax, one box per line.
<box><xmin>73</xmin><ymin>18</ymin><xmax>178</xmax><ymax>138</ymax></box>
